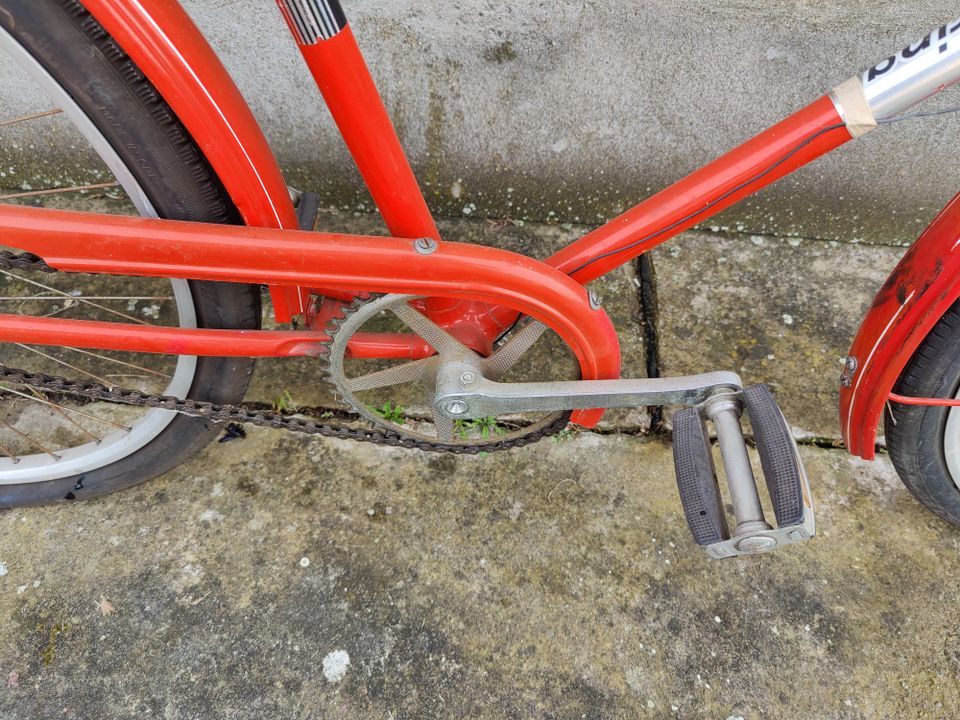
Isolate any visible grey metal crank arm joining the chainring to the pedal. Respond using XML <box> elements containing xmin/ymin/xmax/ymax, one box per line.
<box><xmin>434</xmin><ymin>363</ymin><xmax>742</xmax><ymax>420</ymax></box>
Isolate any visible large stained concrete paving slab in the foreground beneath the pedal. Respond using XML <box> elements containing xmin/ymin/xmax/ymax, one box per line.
<box><xmin>0</xmin><ymin>429</ymin><xmax>960</xmax><ymax>720</ymax></box>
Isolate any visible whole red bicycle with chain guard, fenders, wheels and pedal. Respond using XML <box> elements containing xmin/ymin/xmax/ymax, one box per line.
<box><xmin>0</xmin><ymin>0</ymin><xmax>960</xmax><ymax>557</ymax></box>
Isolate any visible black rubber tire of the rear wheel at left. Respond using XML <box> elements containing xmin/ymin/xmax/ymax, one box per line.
<box><xmin>0</xmin><ymin>0</ymin><xmax>260</xmax><ymax>507</ymax></box>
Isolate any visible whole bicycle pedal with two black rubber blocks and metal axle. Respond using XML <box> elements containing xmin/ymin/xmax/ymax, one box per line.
<box><xmin>673</xmin><ymin>385</ymin><xmax>816</xmax><ymax>559</ymax></box>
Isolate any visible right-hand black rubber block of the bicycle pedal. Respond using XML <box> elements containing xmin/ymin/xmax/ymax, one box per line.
<box><xmin>743</xmin><ymin>385</ymin><xmax>803</xmax><ymax>527</ymax></box>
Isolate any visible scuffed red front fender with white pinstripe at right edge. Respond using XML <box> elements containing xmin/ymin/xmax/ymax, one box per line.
<box><xmin>840</xmin><ymin>195</ymin><xmax>960</xmax><ymax>460</ymax></box>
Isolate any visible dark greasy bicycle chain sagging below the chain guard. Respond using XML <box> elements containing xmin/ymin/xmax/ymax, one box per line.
<box><xmin>0</xmin><ymin>250</ymin><xmax>567</xmax><ymax>455</ymax></box>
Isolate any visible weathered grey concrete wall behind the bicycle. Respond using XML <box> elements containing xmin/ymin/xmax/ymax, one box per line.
<box><xmin>0</xmin><ymin>0</ymin><xmax>960</xmax><ymax>244</ymax></box>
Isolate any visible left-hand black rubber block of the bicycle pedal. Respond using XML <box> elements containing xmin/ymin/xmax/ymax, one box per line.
<box><xmin>673</xmin><ymin>408</ymin><xmax>730</xmax><ymax>545</ymax></box>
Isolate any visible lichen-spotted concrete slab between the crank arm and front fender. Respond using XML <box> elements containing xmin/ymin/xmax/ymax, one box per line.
<box><xmin>653</xmin><ymin>233</ymin><xmax>902</xmax><ymax>439</ymax></box>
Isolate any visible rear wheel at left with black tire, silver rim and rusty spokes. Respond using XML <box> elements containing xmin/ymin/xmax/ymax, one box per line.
<box><xmin>0</xmin><ymin>0</ymin><xmax>260</xmax><ymax>507</ymax></box>
